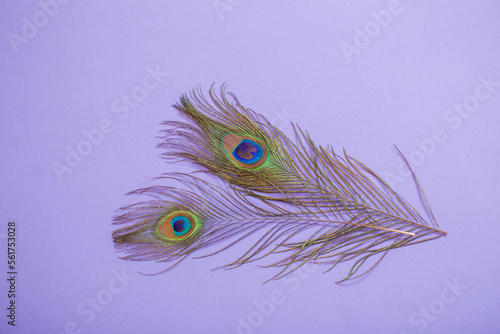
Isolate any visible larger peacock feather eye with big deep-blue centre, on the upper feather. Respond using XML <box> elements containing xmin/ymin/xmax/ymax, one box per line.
<box><xmin>222</xmin><ymin>133</ymin><xmax>268</xmax><ymax>169</ymax></box>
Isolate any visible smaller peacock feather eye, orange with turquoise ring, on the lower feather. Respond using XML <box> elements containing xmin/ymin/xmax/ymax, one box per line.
<box><xmin>155</xmin><ymin>211</ymin><xmax>198</xmax><ymax>241</ymax></box>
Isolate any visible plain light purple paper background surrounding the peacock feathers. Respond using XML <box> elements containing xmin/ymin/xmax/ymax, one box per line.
<box><xmin>0</xmin><ymin>0</ymin><xmax>500</xmax><ymax>334</ymax></box>
